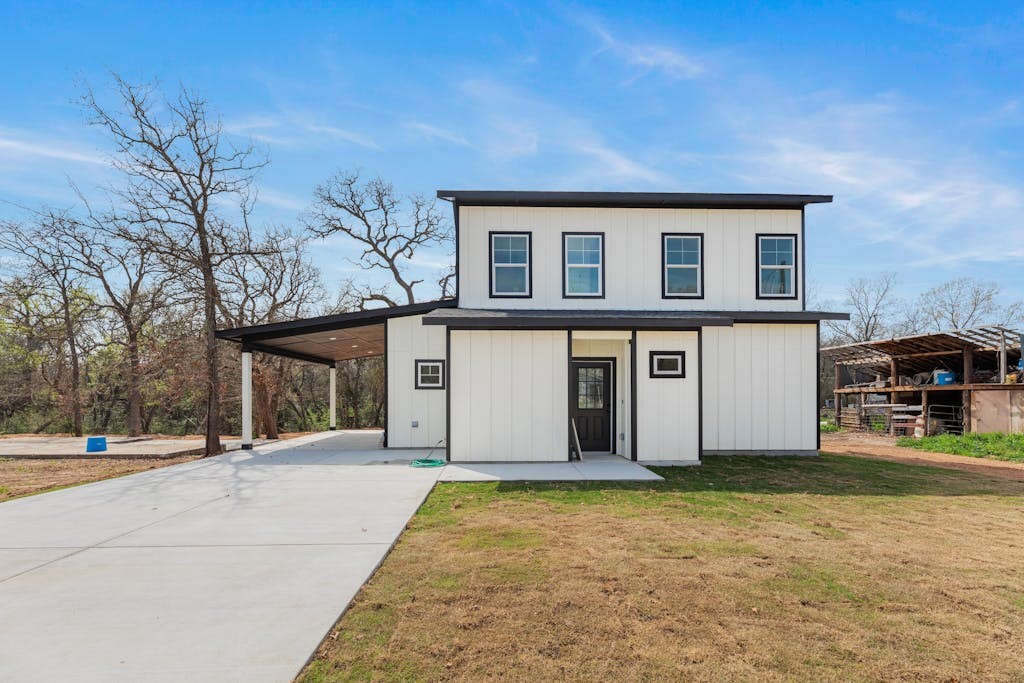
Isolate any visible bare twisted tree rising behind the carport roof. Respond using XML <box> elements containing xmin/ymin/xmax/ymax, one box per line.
<box><xmin>307</xmin><ymin>171</ymin><xmax>451</xmax><ymax>308</ymax></box>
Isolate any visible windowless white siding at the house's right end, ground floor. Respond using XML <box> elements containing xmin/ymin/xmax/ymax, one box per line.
<box><xmin>702</xmin><ymin>324</ymin><xmax>818</xmax><ymax>454</ymax></box>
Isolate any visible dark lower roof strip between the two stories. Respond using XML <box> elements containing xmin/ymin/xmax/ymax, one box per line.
<box><xmin>423</xmin><ymin>308</ymin><xmax>849</xmax><ymax>330</ymax></box>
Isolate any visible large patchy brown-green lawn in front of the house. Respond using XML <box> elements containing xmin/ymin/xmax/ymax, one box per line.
<box><xmin>299</xmin><ymin>455</ymin><xmax>1024</xmax><ymax>683</ymax></box>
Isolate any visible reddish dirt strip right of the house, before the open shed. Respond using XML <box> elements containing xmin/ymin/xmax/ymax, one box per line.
<box><xmin>821</xmin><ymin>431</ymin><xmax>1024</xmax><ymax>481</ymax></box>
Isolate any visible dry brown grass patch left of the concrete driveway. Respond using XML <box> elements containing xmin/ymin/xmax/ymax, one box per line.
<box><xmin>0</xmin><ymin>456</ymin><xmax>199</xmax><ymax>502</ymax></box>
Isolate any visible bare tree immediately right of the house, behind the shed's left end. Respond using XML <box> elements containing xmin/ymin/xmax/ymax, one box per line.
<box><xmin>825</xmin><ymin>272</ymin><xmax>900</xmax><ymax>344</ymax></box>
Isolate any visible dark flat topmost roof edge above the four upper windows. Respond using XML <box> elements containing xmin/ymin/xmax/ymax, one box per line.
<box><xmin>437</xmin><ymin>189</ymin><xmax>833</xmax><ymax>209</ymax></box>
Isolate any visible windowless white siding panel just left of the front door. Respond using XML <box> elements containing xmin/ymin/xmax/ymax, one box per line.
<box><xmin>449</xmin><ymin>330</ymin><xmax>568</xmax><ymax>462</ymax></box>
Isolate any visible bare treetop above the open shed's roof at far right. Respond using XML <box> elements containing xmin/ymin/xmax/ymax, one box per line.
<box><xmin>916</xmin><ymin>278</ymin><xmax>1013</xmax><ymax>332</ymax></box>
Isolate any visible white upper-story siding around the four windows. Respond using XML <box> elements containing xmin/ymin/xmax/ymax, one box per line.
<box><xmin>459</xmin><ymin>202</ymin><xmax>804</xmax><ymax>311</ymax></box>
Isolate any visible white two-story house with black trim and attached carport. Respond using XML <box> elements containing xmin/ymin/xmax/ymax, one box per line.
<box><xmin>221</xmin><ymin>190</ymin><xmax>846</xmax><ymax>463</ymax></box>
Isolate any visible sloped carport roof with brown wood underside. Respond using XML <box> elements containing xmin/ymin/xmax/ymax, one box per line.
<box><xmin>217</xmin><ymin>299</ymin><xmax>456</xmax><ymax>365</ymax></box>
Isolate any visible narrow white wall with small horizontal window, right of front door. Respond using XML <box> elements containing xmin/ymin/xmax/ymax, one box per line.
<box><xmin>637</xmin><ymin>332</ymin><xmax>700</xmax><ymax>463</ymax></box>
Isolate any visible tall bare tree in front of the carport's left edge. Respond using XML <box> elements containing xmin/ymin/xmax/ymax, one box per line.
<box><xmin>81</xmin><ymin>75</ymin><xmax>266</xmax><ymax>455</ymax></box>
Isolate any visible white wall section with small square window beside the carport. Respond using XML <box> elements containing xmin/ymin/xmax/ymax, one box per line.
<box><xmin>387</xmin><ymin>315</ymin><xmax>445</xmax><ymax>447</ymax></box>
